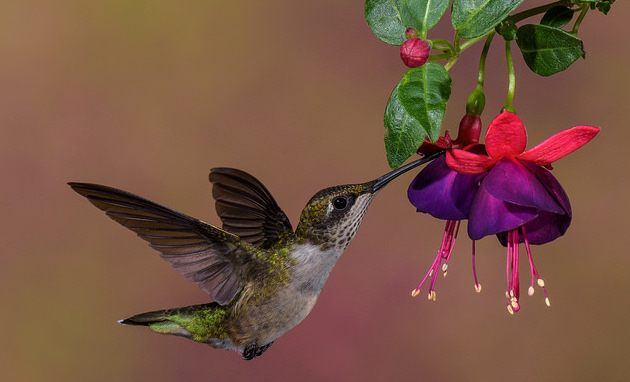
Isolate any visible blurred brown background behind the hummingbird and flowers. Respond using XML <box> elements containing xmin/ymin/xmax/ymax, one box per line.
<box><xmin>0</xmin><ymin>0</ymin><xmax>630</xmax><ymax>382</ymax></box>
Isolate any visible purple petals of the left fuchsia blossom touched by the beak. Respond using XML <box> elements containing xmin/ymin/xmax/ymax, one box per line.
<box><xmin>407</xmin><ymin>155</ymin><xmax>483</xmax><ymax>220</ymax></box>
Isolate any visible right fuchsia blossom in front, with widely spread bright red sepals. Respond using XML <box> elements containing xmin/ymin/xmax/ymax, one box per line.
<box><xmin>445</xmin><ymin>111</ymin><xmax>600</xmax><ymax>314</ymax></box>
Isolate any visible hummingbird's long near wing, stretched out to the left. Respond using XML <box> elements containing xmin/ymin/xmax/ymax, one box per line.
<box><xmin>68</xmin><ymin>183</ymin><xmax>264</xmax><ymax>305</ymax></box>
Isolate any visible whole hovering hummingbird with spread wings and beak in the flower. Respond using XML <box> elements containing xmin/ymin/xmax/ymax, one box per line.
<box><xmin>68</xmin><ymin>153</ymin><xmax>440</xmax><ymax>360</ymax></box>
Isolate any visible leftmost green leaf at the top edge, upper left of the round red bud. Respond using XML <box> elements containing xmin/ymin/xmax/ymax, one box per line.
<box><xmin>365</xmin><ymin>0</ymin><xmax>407</xmax><ymax>45</ymax></box>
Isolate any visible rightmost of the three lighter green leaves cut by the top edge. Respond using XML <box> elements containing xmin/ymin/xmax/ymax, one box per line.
<box><xmin>451</xmin><ymin>0</ymin><xmax>523</xmax><ymax>38</ymax></box>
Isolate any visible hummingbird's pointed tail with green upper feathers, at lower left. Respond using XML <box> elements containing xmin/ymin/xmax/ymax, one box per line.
<box><xmin>118</xmin><ymin>302</ymin><xmax>232</xmax><ymax>349</ymax></box>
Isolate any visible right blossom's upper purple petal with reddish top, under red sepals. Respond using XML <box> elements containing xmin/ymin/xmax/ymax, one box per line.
<box><xmin>484</xmin><ymin>158</ymin><xmax>565</xmax><ymax>214</ymax></box>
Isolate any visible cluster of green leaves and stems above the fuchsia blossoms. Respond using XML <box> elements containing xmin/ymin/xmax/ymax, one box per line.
<box><xmin>365</xmin><ymin>0</ymin><xmax>614</xmax><ymax>168</ymax></box>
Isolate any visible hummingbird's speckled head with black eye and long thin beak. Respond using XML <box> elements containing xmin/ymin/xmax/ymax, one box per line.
<box><xmin>296</xmin><ymin>152</ymin><xmax>441</xmax><ymax>249</ymax></box>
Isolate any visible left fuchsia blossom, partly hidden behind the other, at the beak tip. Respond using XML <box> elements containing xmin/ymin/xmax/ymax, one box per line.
<box><xmin>407</xmin><ymin>113</ymin><xmax>486</xmax><ymax>301</ymax></box>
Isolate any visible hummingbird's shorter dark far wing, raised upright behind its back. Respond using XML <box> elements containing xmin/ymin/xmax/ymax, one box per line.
<box><xmin>209</xmin><ymin>167</ymin><xmax>293</xmax><ymax>248</ymax></box>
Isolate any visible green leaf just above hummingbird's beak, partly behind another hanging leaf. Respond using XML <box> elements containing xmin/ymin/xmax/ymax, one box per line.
<box><xmin>384</xmin><ymin>82</ymin><xmax>426</xmax><ymax>168</ymax></box>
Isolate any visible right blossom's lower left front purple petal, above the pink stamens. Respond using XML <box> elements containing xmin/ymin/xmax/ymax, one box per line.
<box><xmin>468</xmin><ymin>181</ymin><xmax>538</xmax><ymax>240</ymax></box>
